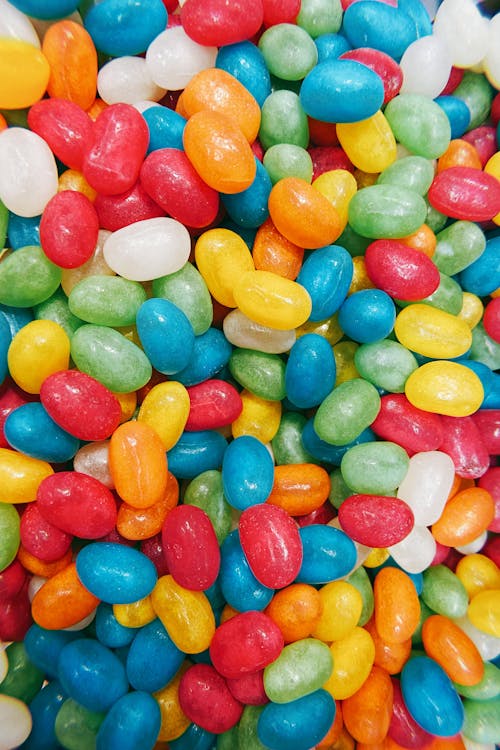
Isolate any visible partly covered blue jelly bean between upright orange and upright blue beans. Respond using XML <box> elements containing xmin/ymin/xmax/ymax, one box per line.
<box><xmin>167</xmin><ymin>430</ymin><xmax>227</xmax><ymax>479</ymax></box>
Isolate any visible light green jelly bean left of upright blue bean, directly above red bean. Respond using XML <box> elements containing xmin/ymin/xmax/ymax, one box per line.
<box><xmin>71</xmin><ymin>323</ymin><xmax>153</xmax><ymax>393</ymax></box>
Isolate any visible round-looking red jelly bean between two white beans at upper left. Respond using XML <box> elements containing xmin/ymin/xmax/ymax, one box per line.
<box><xmin>40</xmin><ymin>190</ymin><xmax>99</xmax><ymax>268</ymax></box>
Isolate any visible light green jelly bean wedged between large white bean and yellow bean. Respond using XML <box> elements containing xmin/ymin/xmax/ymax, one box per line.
<box><xmin>152</xmin><ymin>261</ymin><xmax>213</xmax><ymax>336</ymax></box>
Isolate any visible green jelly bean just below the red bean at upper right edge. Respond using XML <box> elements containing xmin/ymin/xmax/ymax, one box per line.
<box><xmin>432</xmin><ymin>221</ymin><xmax>486</xmax><ymax>276</ymax></box>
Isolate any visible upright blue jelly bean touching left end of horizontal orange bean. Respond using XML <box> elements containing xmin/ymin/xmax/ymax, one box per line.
<box><xmin>222</xmin><ymin>435</ymin><xmax>274</xmax><ymax>510</ymax></box>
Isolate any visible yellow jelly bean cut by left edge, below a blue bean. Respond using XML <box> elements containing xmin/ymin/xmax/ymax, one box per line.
<box><xmin>0</xmin><ymin>448</ymin><xmax>54</xmax><ymax>504</ymax></box>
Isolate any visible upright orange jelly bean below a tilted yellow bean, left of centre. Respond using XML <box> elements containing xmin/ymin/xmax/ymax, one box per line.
<box><xmin>109</xmin><ymin>422</ymin><xmax>168</xmax><ymax>508</ymax></box>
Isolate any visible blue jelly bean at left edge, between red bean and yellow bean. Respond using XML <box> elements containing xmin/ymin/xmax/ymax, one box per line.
<box><xmin>0</xmin><ymin>406</ymin><xmax>80</xmax><ymax>464</ymax></box>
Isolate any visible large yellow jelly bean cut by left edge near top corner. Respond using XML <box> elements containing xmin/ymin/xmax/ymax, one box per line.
<box><xmin>0</xmin><ymin>38</ymin><xmax>50</xmax><ymax>109</ymax></box>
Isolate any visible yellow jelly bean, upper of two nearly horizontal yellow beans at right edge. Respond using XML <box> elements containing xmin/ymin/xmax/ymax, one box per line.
<box><xmin>394</xmin><ymin>303</ymin><xmax>472</xmax><ymax>359</ymax></box>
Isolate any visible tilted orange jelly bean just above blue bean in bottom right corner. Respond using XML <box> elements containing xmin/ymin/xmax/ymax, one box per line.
<box><xmin>422</xmin><ymin>615</ymin><xmax>484</xmax><ymax>685</ymax></box>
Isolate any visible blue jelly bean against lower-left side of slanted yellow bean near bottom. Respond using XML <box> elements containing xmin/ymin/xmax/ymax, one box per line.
<box><xmin>127</xmin><ymin>619</ymin><xmax>185</xmax><ymax>693</ymax></box>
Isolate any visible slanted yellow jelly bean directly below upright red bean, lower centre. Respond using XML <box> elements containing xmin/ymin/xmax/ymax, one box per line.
<box><xmin>151</xmin><ymin>574</ymin><xmax>215</xmax><ymax>654</ymax></box>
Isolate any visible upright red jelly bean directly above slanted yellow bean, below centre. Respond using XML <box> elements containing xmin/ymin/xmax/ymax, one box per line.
<box><xmin>162</xmin><ymin>505</ymin><xmax>220</xmax><ymax>591</ymax></box>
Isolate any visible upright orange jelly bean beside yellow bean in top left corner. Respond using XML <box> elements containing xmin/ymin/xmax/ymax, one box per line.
<box><xmin>42</xmin><ymin>20</ymin><xmax>97</xmax><ymax>109</ymax></box>
